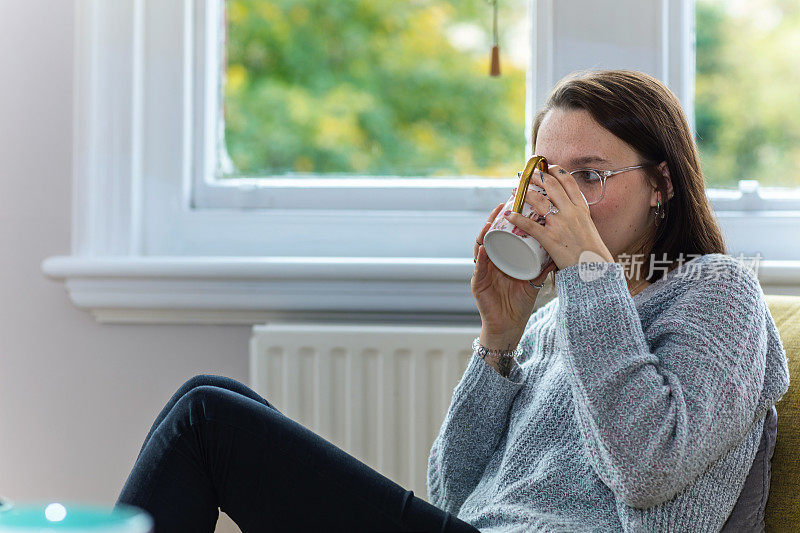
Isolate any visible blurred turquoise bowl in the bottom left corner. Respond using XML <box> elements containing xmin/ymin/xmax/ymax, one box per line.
<box><xmin>0</xmin><ymin>500</ymin><xmax>153</xmax><ymax>533</ymax></box>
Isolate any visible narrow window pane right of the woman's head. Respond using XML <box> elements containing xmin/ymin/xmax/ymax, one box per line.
<box><xmin>695</xmin><ymin>0</ymin><xmax>800</xmax><ymax>188</ymax></box>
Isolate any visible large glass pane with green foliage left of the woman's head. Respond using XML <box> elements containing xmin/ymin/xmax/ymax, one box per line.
<box><xmin>220</xmin><ymin>0</ymin><xmax>530</xmax><ymax>178</ymax></box>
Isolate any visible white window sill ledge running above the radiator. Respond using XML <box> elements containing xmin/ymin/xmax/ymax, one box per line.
<box><xmin>42</xmin><ymin>256</ymin><xmax>800</xmax><ymax>324</ymax></box>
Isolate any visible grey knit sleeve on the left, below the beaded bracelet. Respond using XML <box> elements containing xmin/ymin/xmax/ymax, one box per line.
<box><xmin>427</xmin><ymin>336</ymin><xmax>526</xmax><ymax>515</ymax></box>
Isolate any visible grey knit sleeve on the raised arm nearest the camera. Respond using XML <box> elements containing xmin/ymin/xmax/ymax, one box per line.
<box><xmin>556</xmin><ymin>254</ymin><xmax>768</xmax><ymax>508</ymax></box>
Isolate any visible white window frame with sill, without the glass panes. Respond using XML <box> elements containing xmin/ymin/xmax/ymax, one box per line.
<box><xmin>43</xmin><ymin>0</ymin><xmax>800</xmax><ymax>323</ymax></box>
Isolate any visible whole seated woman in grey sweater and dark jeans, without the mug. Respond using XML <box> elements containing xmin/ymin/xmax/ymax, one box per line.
<box><xmin>118</xmin><ymin>71</ymin><xmax>789</xmax><ymax>533</ymax></box>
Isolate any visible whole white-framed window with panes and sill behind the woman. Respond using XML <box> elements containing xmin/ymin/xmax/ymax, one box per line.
<box><xmin>43</xmin><ymin>0</ymin><xmax>800</xmax><ymax>323</ymax></box>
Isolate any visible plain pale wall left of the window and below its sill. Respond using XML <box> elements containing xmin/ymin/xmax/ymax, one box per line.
<box><xmin>0</xmin><ymin>0</ymin><xmax>250</xmax><ymax>528</ymax></box>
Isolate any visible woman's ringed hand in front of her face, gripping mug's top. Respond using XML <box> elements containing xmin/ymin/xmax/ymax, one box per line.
<box><xmin>504</xmin><ymin>165</ymin><xmax>614</xmax><ymax>269</ymax></box>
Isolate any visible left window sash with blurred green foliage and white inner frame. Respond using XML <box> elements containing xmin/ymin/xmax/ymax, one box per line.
<box><xmin>192</xmin><ymin>0</ymin><xmax>531</xmax><ymax>211</ymax></box>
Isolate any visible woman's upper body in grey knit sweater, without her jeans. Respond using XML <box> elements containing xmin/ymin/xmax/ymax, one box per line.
<box><xmin>428</xmin><ymin>71</ymin><xmax>789</xmax><ymax>532</ymax></box>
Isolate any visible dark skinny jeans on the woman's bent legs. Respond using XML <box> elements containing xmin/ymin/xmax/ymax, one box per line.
<box><xmin>117</xmin><ymin>375</ymin><xmax>478</xmax><ymax>533</ymax></box>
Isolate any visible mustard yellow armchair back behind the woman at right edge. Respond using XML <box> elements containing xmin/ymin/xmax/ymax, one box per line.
<box><xmin>764</xmin><ymin>294</ymin><xmax>800</xmax><ymax>533</ymax></box>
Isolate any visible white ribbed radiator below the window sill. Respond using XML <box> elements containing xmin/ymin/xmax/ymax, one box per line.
<box><xmin>250</xmin><ymin>323</ymin><xmax>480</xmax><ymax>499</ymax></box>
